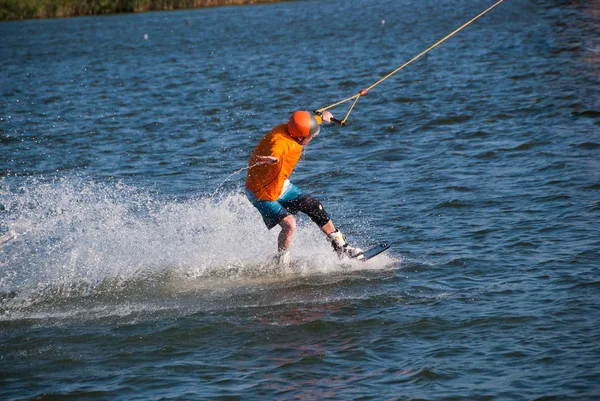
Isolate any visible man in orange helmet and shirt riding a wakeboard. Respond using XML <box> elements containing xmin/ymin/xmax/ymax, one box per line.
<box><xmin>246</xmin><ymin>111</ymin><xmax>362</xmax><ymax>264</ymax></box>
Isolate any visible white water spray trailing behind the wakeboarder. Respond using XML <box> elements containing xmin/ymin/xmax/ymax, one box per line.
<box><xmin>0</xmin><ymin>177</ymin><xmax>398</xmax><ymax>315</ymax></box>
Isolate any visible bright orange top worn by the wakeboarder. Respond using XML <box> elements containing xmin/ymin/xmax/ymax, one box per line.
<box><xmin>246</xmin><ymin>124</ymin><xmax>302</xmax><ymax>201</ymax></box>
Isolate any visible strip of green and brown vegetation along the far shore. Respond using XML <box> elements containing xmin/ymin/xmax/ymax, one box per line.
<box><xmin>0</xmin><ymin>0</ymin><xmax>277</xmax><ymax>21</ymax></box>
